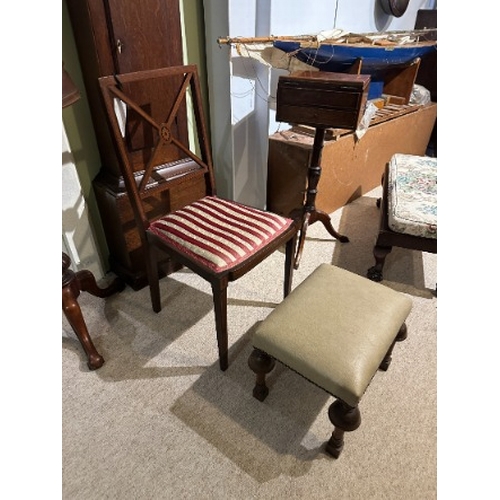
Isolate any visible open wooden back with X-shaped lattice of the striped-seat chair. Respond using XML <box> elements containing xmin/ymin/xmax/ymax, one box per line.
<box><xmin>99</xmin><ymin>65</ymin><xmax>216</xmax><ymax>242</ymax></box>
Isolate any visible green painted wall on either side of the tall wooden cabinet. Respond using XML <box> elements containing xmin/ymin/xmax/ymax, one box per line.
<box><xmin>62</xmin><ymin>0</ymin><xmax>210</xmax><ymax>271</ymax></box>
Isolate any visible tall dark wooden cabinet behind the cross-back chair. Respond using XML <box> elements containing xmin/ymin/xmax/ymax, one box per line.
<box><xmin>66</xmin><ymin>0</ymin><xmax>201</xmax><ymax>289</ymax></box>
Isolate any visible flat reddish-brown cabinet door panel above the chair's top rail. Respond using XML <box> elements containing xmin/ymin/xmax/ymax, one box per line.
<box><xmin>107</xmin><ymin>0</ymin><xmax>183</xmax><ymax>73</ymax></box>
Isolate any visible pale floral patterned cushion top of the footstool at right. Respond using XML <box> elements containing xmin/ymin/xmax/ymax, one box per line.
<box><xmin>388</xmin><ymin>154</ymin><xmax>437</xmax><ymax>239</ymax></box>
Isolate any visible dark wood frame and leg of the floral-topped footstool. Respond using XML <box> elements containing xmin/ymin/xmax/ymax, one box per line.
<box><xmin>366</xmin><ymin>162</ymin><xmax>437</xmax><ymax>281</ymax></box>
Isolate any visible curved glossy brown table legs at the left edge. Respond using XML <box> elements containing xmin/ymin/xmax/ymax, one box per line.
<box><xmin>62</xmin><ymin>252</ymin><xmax>125</xmax><ymax>370</ymax></box>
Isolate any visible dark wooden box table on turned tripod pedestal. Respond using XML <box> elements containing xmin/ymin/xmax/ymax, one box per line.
<box><xmin>276</xmin><ymin>71</ymin><xmax>370</xmax><ymax>269</ymax></box>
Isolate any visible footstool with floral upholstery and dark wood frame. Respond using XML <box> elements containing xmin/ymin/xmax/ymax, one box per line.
<box><xmin>367</xmin><ymin>153</ymin><xmax>437</xmax><ymax>281</ymax></box>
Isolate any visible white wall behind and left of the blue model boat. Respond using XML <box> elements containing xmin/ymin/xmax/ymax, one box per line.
<box><xmin>204</xmin><ymin>0</ymin><xmax>437</xmax><ymax>208</ymax></box>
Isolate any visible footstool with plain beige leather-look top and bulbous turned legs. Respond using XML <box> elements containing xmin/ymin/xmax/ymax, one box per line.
<box><xmin>248</xmin><ymin>264</ymin><xmax>412</xmax><ymax>458</ymax></box>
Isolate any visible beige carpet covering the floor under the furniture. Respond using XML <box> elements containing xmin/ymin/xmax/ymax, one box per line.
<box><xmin>62</xmin><ymin>189</ymin><xmax>437</xmax><ymax>500</ymax></box>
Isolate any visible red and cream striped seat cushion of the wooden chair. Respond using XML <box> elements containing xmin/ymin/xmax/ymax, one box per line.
<box><xmin>149</xmin><ymin>196</ymin><xmax>293</xmax><ymax>273</ymax></box>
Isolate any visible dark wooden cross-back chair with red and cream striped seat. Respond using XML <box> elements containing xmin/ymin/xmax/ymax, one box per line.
<box><xmin>99</xmin><ymin>65</ymin><xmax>298</xmax><ymax>370</ymax></box>
